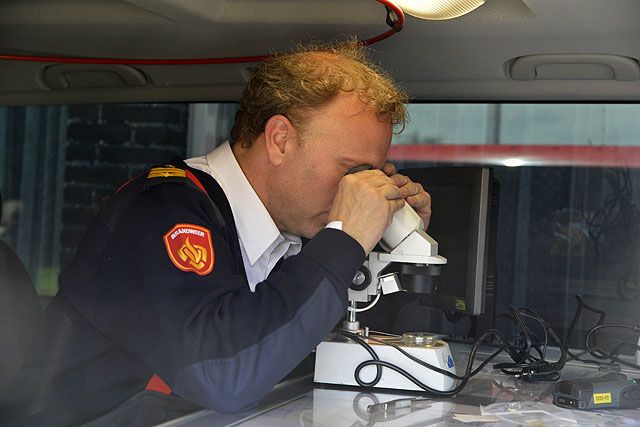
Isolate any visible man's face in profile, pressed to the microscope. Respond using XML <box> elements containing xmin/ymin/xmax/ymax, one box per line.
<box><xmin>270</xmin><ymin>93</ymin><xmax>393</xmax><ymax>238</ymax></box>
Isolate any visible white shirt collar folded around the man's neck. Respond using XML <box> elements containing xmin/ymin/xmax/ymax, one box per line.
<box><xmin>205</xmin><ymin>141</ymin><xmax>301</xmax><ymax>265</ymax></box>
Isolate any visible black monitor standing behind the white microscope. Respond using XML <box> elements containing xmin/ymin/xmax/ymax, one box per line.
<box><xmin>400</xmin><ymin>167</ymin><xmax>499</xmax><ymax>316</ymax></box>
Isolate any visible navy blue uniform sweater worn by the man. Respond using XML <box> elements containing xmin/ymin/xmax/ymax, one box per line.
<box><xmin>3</xmin><ymin>164</ymin><xmax>365</xmax><ymax>426</ymax></box>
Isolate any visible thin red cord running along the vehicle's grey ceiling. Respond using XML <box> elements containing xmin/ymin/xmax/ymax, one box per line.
<box><xmin>0</xmin><ymin>0</ymin><xmax>404</xmax><ymax>65</ymax></box>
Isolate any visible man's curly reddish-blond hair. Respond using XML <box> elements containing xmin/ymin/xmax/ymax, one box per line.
<box><xmin>231</xmin><ymin>41</ymin><xmax>408</xmax><ymax>147</ymax></box>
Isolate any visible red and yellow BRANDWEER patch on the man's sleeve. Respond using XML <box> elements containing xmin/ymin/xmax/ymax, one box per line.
<box><xmin>164</xmin><ymin>224</ymin><xmax>215</xmax><ymax>276</ymax></box>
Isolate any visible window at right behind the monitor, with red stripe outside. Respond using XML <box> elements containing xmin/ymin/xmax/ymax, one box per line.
<box><xmin>390</xmin><ymin>104</ymin><xmax>640</xmax><ymax>350</ymax></box>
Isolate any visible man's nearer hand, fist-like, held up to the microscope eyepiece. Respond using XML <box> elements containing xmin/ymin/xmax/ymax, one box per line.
<box><xmin>328</xmin><ymin>170</ymin><xmax>406</xmax><ymax>254</ymax></box>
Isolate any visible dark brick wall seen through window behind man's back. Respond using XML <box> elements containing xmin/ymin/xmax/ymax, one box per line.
<box><xmin>60</xmin><ymin>104</ymin><xmax>189</xmax><ymax>268</ymax></box>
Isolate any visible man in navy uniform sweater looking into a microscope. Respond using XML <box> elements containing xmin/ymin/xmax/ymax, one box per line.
<box><xmin>3</xmin><ymin>47</ymin><xmax>430</xmax><ymax>425</ymax></box>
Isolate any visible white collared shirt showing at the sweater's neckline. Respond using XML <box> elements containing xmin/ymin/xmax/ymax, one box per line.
<box><xmin>185</xmin><ymin>142</ymin><xmax>302</xmax><ymax>292</ymax></box>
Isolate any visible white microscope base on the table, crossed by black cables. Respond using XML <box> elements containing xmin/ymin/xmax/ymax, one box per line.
<box><xmin>314</xmin><ymin>335</ymin><xmax>456</xmax><ymax>391</ymax></box>
